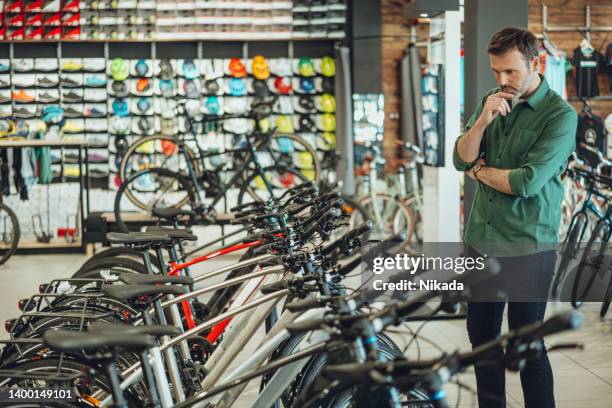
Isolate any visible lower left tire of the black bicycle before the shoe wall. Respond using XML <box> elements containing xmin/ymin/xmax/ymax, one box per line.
<box><xmin>113</xmin><ymin>168</ymin><xmax>194</xmax><ymax>232</ymax></box>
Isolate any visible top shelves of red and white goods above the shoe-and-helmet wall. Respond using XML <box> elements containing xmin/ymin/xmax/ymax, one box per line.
<box><xmin>0</xmin><ymin>0</ymin><xmax>347</xmax><ymax>41</ymax></box>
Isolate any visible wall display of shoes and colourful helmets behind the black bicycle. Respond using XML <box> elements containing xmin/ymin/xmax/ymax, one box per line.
<box><xmin>0</xmin><ymin>43</ymin><xmax>336</xmax><ymax>196</ymax></box>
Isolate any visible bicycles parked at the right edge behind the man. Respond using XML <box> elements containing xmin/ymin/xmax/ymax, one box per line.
<box><xmin>551</xmin><ymin>144</ymin><xmax>612</xmax><ymax>319</ymax></box>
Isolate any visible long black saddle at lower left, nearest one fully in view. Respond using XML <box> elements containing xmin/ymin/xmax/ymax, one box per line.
<box><xmin>43</xmin><ymin>330</ymin><xmax>155</xmax><ymax>351</ymax></box>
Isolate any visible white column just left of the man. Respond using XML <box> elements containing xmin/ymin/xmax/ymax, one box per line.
<box><xmin>423</xmin><ymin>11</ymin><xmax>461</xmax><ymax>242</ymax></box>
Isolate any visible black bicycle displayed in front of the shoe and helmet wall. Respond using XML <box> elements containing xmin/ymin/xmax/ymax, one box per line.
<box><xmin>115</xmin><ymin>98</ymin><xmax>320</xmax><ymax>217</ymax></box>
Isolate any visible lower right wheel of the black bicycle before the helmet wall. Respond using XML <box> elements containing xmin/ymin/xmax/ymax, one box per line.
<box><xmin>238</xmin><ymin>164</ymin><xmax>307</xmax><ymax>204</ymax></box>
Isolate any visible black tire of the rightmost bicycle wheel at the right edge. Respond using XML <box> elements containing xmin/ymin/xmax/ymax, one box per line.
<box><xmin>570</xmin><ymin>220</ymin><xmax>610</xmax><ymax>309</ymax></box>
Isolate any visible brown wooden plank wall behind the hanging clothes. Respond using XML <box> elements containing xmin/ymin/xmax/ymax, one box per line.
<box><xmin>381</xmin><ymin>0</ymin><xmax>612</xmax><ymax>151</ymax></box>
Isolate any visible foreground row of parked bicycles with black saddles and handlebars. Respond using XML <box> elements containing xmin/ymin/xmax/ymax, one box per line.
<box><xmin>0</xmin><ymin>181</ymin><xmax>580</xmax><ymax>408</ymax></box>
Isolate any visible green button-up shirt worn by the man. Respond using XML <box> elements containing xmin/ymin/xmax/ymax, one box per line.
<box><xmin>453</xmin><ymin>77</ymin><xmax>578</xmax><ymax>256</ymax></box>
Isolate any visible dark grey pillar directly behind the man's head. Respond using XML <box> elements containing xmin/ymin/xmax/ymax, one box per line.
<box><xmin>462</xmin><ymin>0</ymin><xmax>529</xmax><ymax>233</ymax></box>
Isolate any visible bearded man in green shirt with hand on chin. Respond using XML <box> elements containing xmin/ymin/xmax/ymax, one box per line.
<box><xmin>453</xmin><ymin>28</ymin><xmax>577</xmax><ymax>408</ymax></box>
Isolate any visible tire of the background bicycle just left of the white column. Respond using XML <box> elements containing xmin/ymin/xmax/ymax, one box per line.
<box><xmin>359</xmin><ymin>193</ymin><xmax>414</xmax><ymax>243</ymax></box>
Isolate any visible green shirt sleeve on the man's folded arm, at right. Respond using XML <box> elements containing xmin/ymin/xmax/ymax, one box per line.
<box><xmin>509</xmin><ymin>110</ymin><xmax>578</xmax><ymax>197</ymax></box>
